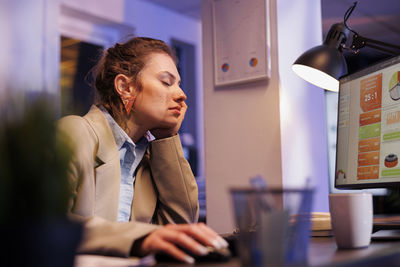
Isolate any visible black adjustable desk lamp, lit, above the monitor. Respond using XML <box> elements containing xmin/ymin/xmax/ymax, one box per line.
<box><xmin>292</xmin><ymin>1</ymin><xmax>400</xmax><ymax>92</ymax></box>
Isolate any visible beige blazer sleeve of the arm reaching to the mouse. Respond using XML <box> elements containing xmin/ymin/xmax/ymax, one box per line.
<box><xmin>57</xmin><ymin>116</ymin><xmax>159</xmax><ymax>257</ymax></box>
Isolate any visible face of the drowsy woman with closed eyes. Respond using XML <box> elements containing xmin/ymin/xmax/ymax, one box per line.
<box><xmin>133</xmin><ymin>53</ymin><xmax>186</xmax><ymax>130</ymax></box>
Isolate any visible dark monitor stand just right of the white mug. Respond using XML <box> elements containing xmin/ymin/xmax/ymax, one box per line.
<box><xmin>372</xmin><ymin>214</ymin><xmax>400</xmax><ymax>241</ymax></box>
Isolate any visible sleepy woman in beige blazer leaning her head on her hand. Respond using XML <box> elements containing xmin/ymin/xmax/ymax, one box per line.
<box><xmin>59</xmin><ymin>37</ymin><xmax>227</xmax><ymax>262</ymax></box>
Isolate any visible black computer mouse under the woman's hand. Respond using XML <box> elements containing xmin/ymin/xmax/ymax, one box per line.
<box><xmin>155</xmin><ymin>247</ymin><xmax>232</xmax><ymax>262</ymax></box>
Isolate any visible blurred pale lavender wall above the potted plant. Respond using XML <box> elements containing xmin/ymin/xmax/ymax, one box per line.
<box><xmin>0</xmin><ymin>0</ymin><xmax>59</xmax><ymax>101</ymax></box>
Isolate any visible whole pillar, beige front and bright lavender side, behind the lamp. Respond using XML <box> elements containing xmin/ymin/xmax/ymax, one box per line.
<box><xmin>202</xmin><ymin>0</ymin><xmax>328</xmax><ymax>233</ymax></box>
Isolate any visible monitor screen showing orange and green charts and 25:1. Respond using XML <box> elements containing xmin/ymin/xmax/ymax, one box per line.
<box><xmin>335</xmin><ymin>56</ymin><xmax>400</xmax><ymax>188</ymax></box>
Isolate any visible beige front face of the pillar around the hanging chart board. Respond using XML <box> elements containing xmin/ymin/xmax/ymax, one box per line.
<box><xmin>202</xmin><ymin>0</ymin><xmax>282</xmax><ymax>233</ymax></box>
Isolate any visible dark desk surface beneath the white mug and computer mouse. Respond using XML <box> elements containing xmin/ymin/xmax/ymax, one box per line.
<box><xmin>156</xmin><ymin>237</ymin><xmax>400</xmax><ymax>267</ymax></box>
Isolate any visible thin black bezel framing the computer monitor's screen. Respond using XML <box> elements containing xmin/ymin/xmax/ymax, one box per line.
<box><xmin>334</xmin><ymin>55</ymin><xmax>400</xmax><ymax>189</ymax></box>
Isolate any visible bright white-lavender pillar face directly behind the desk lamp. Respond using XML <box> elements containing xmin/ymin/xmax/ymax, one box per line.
<box><xmin>271</xmin><ymin>0</ymin><xmax>329</xmax><ymax>211</ymax></box>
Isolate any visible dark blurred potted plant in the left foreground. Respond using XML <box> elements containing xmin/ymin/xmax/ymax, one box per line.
<box><xmin>0</xmin><ymin>97</ymin><xmax>81</xmax><ymax>266</ymax></box>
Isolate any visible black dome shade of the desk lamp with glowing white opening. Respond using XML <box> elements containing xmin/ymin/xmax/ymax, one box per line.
<box><xmin>292</xmin><ymin>44</ymin><xmax>347</xmax><ymax>92</ymax></box>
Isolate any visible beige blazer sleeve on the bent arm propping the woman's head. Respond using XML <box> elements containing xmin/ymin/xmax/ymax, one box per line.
<box><xmin>150</xmin><ymin>135</ymin><xmax>199</xmax><ymax>224</ymax></box>
